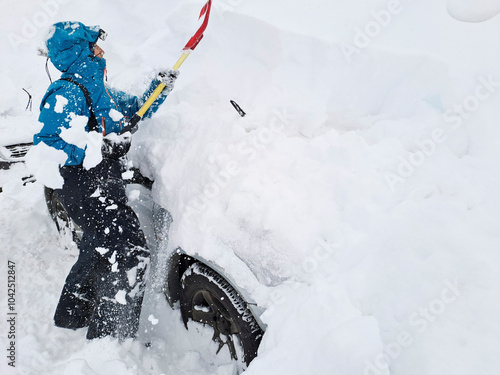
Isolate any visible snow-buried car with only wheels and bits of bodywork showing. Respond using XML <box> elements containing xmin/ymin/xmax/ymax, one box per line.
<box><xmin>0</xmin><ymin>143</ymin><xmax>265</xmax><ymax>369</ymax></box>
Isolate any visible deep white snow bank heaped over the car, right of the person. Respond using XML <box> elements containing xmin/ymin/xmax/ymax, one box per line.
<box><xmin>131</xmin><ymin>3</ymin><xmax>499</xmax><ymax>374</ymax></box>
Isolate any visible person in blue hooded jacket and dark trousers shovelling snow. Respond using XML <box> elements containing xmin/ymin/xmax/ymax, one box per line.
<box><xmin>33</xmin><ymin>22</ymin><xmax>178</xmax><ymax>339</ymax></box>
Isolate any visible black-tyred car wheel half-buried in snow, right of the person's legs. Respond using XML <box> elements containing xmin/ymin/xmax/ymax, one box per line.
<box><xmin>180</xmin><ymin>263</ymin><xmax>264</xmax><ymax>366</ymax></box>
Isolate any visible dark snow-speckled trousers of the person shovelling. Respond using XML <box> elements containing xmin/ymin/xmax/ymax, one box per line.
<box><xmin>54</xmin><ymin>159</ymin><xmax>149</xmax><ymax>339</ymax></box>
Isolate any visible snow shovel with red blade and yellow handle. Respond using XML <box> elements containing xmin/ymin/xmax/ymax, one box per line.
<box><xmin>124</xmin><ymin>0</ymin><xmax>212</xmax><ymax>134</ymax></box>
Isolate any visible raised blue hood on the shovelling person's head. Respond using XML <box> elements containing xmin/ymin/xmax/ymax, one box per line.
<box><xmin>46</xmin><ymin>21</ymin><xmax>101</xmax><ymax>72</ymax></box>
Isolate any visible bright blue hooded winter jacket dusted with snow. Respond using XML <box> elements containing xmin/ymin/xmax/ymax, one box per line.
<box><xmin>33</xmin><ymin>22</ymin><xmax>167</xmax><ymax>165</ymax></box>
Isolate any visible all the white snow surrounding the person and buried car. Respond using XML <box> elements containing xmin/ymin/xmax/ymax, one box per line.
<box><xmin>0</xmin><ymin>0</ymin><xmax>500</xmax><ymax>375</ymax></box>
